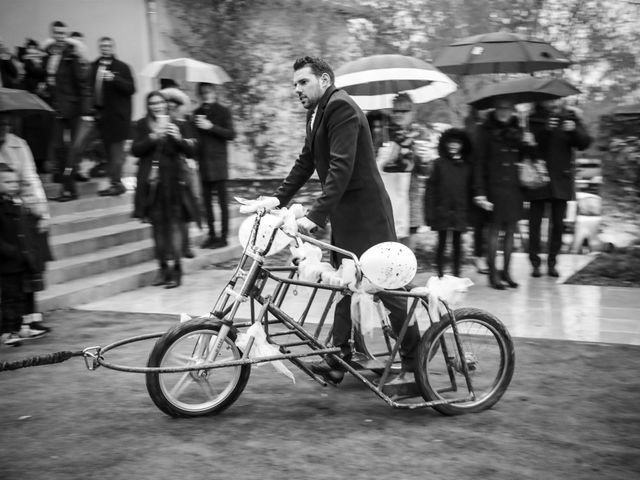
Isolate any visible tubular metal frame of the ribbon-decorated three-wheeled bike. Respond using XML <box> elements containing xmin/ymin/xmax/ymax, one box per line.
<box><xmin>200</xmin><ymin>209</ymin><xmax>475</xmax><ymax>409</ymax></box>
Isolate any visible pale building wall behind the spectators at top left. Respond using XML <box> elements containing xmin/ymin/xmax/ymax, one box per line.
<box><xmin>0</xmin><ymin>0</ymin><xmax>152</xmax><ymax>118</ymax></box>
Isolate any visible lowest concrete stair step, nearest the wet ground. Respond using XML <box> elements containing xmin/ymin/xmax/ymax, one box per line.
<box><xmin>37</xmin><ymin>241</ymin><xmax>242</xmax><ymax>312</ymax></box>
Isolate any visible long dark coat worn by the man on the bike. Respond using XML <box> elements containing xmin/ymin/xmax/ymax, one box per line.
<box><xmin>275</xmin><ymin>86</ymin><xmax>397</xmax><ymax>262</ymax></box>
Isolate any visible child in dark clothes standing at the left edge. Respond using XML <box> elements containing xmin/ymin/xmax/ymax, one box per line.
<box><xmin>0</xmin><ymin>163</ymin><xmax>47</xmax><ymax>345</ymax></box>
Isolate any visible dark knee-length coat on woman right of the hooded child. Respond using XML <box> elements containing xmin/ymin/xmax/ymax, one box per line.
<box><xmin>474</xmin><ymin>112</ymin><xmax>526</xmax><ymax>225</ymax></box>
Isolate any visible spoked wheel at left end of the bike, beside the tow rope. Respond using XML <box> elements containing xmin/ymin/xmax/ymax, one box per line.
<box><xmin>146</xmin><ymin>320</ymin><xmax>251</xmax><ymax>417</ymax></box>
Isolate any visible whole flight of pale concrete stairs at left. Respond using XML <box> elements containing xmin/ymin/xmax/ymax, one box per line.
<box><xmin>37</xmin><ymin>179</ymin><xmax>242</xmax><ymax>312</ymax></box>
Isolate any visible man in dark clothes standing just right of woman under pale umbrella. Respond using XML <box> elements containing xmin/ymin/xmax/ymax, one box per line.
<box><xmin>193</xmin><ymin>83</ymin><xmax>236</xmax><ymax>248</ymax></box>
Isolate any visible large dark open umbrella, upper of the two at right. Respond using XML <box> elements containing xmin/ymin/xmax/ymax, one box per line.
<box><xmin>433</xmin><ymin>32</ymin><xmax>573</xmax><ymax>75</ymax></box>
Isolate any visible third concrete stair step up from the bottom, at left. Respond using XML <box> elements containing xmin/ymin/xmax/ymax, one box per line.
<box><xmin>50</xmin><ymin>220</ymin><xmax>151</xmax><ymax>260</ymax></box>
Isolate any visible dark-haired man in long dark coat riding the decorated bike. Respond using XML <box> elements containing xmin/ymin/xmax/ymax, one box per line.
<box><xmin>275</xmin><ymin>57</ymin><xmax>419</xmax><ymax>383</ymax></box>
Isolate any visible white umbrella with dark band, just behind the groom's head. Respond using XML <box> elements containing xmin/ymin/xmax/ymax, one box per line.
<box><xmin>335</xmin><ymin>55</ymin><xmax>457</xmax><ymax>110</ymax></box>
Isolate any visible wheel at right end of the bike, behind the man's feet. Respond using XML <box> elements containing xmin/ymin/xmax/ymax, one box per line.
<box><xmin>415</xmin><ymin>308</ymin><xmax>515</xmax><ymax>415</ymax></box>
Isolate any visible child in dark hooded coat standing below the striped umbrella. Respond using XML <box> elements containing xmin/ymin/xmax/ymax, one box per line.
<box><xmin>424</xmin><ymin>128</ymin><xmax>472</xmax><ymax>277</ymax></box>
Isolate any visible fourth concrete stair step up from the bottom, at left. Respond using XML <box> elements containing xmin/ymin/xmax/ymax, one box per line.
<box><xmin>49</xmin><ymin>203</ymin><xmax>133</xmax><ymax>235</ymax></box>
